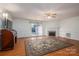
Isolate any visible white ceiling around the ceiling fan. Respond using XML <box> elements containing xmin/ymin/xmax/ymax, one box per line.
<box><xmin>0</xmin><ymin>3</ymin><xmax>79</xmax><ymax>21</ymax></box>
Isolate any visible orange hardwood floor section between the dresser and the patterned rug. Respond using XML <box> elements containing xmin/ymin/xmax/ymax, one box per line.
<box><xmin>0</xmin><ymin>39</ymin><xmax>25</xmax><ymax>56</ymax></box>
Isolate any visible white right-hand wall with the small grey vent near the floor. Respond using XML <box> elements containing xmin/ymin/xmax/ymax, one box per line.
<box><xmin>60</xmin><ymin>17</ymin><xmax>79</xmax><ymax>40</ymax></box>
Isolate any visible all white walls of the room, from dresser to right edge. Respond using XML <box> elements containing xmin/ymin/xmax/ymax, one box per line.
<box><xmin>13</xmin><ymin>17</ymin><xmax>79</xmax><ymax>39</ymax></box>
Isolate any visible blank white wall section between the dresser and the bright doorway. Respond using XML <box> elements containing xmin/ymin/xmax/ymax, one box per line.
<box><xmin>13</xmin><ymin>19</ymin><xmax>31</xmax><ymax>37</ymax></box>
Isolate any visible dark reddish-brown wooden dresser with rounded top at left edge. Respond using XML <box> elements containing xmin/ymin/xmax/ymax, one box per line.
<box><xmin>0</xmin><ymin>29</ymin><xmax>16</xmax><ymax>50</ymax></box>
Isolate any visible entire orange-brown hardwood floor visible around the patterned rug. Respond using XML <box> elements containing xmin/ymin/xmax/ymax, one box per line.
<box><xmin>0</xmin><ymin>37</ymin><xmax>79</xmax><ymax>56</ymax></box>
